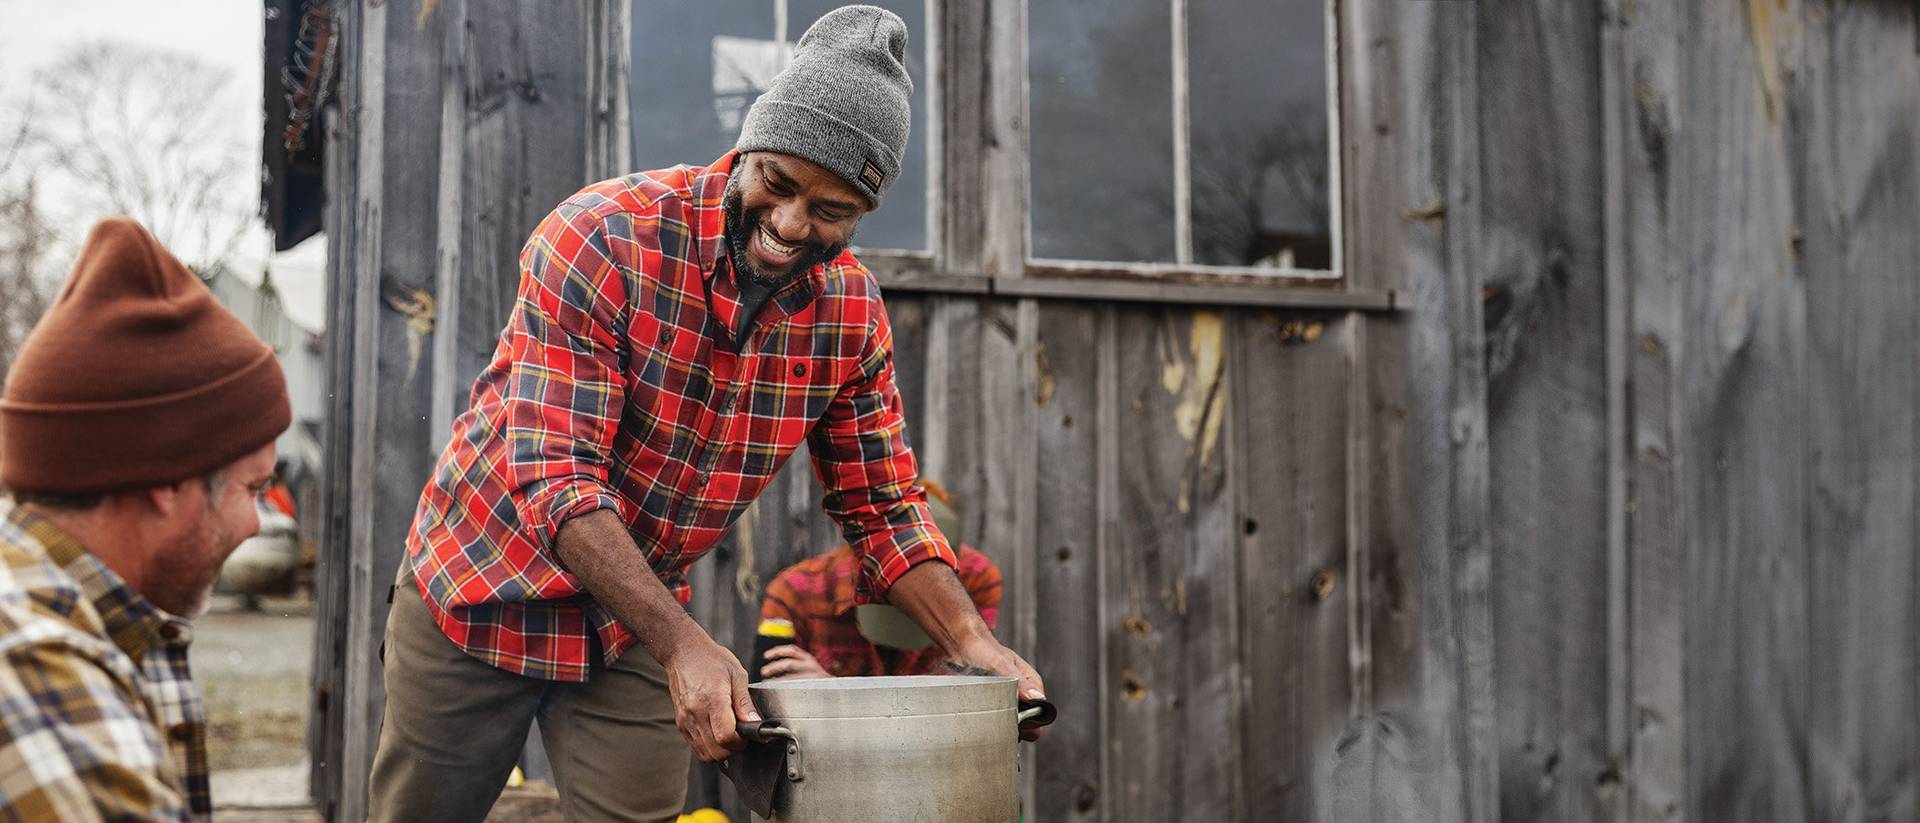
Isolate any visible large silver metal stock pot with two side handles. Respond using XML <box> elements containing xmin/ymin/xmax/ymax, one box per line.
<box><xmin>722</xmin><ymin>675</ymin><xmax>1052</xmax><ymax>823</ymax></box>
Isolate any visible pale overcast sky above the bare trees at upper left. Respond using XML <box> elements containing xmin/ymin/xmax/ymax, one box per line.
<box><xmin>0</xmin><ymin>0</ymin><xmax>324</xmax><ymax>328</ymax></box>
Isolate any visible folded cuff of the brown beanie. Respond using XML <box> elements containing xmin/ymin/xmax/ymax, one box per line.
<box><xmin>0</xmin><ymin>347</ymin><xmax>294</xmax><ymax>495</ymax></box>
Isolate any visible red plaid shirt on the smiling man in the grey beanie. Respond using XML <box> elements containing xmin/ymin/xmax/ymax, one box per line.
<box><xmin>407</xmin><ymin>153</ymin><xmax>954</xmax><ymax>681</ymax></box>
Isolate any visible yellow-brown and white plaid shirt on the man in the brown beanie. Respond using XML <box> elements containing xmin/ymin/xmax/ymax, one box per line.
<box><xmin>0</xmin><ymin>499</ymin><xmax>213</xmax><ymax>821</ymax></box>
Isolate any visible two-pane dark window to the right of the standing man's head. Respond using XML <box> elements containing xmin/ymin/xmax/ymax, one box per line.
<box><xmin>1027</xmin><ymin>0</ymin><xmax>1336</xmax><ymax>272</ymax></box>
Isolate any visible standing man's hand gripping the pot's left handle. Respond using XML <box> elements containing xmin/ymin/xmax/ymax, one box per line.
<box><xmin>660</xmin><ymin>635</ymin><xmax>760</xmax><ymax>764</ymax></box>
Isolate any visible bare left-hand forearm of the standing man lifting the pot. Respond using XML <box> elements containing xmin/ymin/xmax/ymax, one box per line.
<box><xmin>555</xmin><ymin>508</ymin><xmax>707</xmax><ymax>662</ymax></box>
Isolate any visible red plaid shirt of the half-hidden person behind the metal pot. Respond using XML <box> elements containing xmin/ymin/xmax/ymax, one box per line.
<box><xmin>755</xmin><ymin>545</ymin><xmax>1000</xmax><ymax>677</ymax></box>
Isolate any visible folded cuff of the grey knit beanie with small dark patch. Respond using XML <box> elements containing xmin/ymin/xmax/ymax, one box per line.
<box><xmin>733</xmin><ymin>98</ymin><xmax>900</xmax><ymax>211</ymax></box>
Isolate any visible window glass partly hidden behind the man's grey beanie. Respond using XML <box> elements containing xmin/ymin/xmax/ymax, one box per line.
<box><xmin>630</xmin><ymin>0</ymin><xmax>929</xmax><ymax>249</ymax></box>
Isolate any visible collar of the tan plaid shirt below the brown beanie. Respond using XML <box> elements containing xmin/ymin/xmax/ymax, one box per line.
<box><xmin>8</xmin><ymin>501</ymin><xmax>194</xmax><ymax>662</ymax></box>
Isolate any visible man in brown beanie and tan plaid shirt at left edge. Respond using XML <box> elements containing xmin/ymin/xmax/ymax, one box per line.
<box><xmin>0</xmin><ymin>219</ymin><xmax>292</xmax><ymax>821</ymax></box>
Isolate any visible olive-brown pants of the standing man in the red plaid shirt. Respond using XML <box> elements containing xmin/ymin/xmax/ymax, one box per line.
<box><xmin>369</xmin><ymin>583</ymin><xmax>689</xmax><ymax>823</ymax></box>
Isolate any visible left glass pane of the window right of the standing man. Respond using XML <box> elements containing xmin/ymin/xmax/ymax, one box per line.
<box><xmin>1027</xmin><ymin>0</ymin><xmax>1175</xmax><ymax>261</ymax></box>
